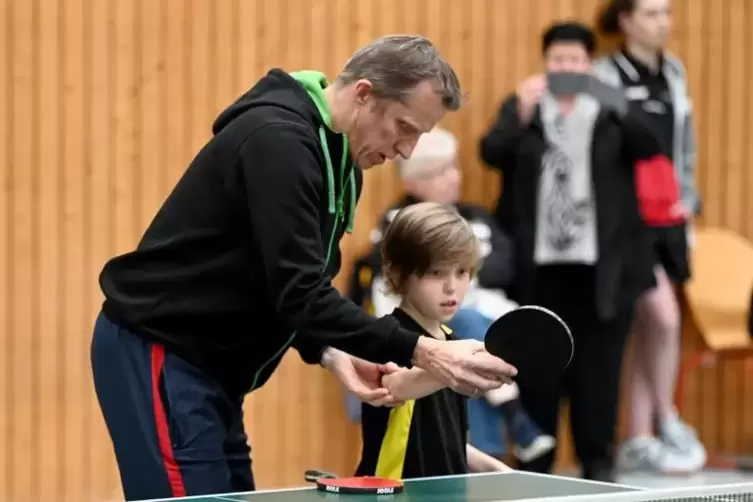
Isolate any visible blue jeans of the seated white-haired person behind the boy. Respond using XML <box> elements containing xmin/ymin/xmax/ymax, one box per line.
<box><xmin>448</xmin><ymin>308</ymin><xmax>505</xmax><ymax>457</ymax></box>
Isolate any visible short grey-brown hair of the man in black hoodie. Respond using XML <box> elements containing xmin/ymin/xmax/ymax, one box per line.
<box><xmin>337</xmin><ymin>35</ymin><xmax>463</xmax><ymax>111</ymax></box>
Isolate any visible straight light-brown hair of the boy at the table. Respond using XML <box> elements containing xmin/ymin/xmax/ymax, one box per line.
<box><xmin>382</xmin><ymin>202</ymin><xmax>479</xmax><ymax>295</ymax></box>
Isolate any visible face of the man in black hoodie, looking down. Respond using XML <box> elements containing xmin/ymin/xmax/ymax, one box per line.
<box><xmin>348</xmin><ymin>80</ymin><xmax>445</xmax><ymax>169</ymax></box>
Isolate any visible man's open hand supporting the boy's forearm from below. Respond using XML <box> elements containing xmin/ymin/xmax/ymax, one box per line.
<box><xmin>322</xmin><ymin>347</ymin><xmax>400</xmax><ymax>406</ymax></box>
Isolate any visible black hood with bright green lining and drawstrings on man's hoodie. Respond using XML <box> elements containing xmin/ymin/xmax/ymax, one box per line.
<box><xmin>212</xmin><ymin>69</ymin><xmax>356</xmax><ymax>237</ymax></box>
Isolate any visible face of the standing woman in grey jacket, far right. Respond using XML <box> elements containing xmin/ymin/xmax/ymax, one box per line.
<box><xmin>622</xmin><ymin>0</ymin><xmax>672</xmax><ymax>51</ymax></box>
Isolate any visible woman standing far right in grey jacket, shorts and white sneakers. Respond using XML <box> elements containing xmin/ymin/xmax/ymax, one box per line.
<box><xmin>595</xmin><ymin>0</ymin><xmax>706</xmax><ymax>473</ymax></box>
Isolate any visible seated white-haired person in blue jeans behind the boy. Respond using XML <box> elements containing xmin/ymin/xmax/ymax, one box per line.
<box><xmin>354</xmin><ymin>127</ymin><xmax>555</xmax><ymax>462</ymax></box>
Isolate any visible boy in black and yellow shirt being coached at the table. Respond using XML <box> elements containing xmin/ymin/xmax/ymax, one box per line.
<box><xmin>356</xmin><ymin>202</ymin><xmax>509</xmax><ymax>479</ymax></box>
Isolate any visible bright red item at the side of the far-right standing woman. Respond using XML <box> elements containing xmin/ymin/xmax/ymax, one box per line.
<box><xmin>635</xmin><ymin>155</ymin><xmax>684</xmax><ymax>227</ymax></box>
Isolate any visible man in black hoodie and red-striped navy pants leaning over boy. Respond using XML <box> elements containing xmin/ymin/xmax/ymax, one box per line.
<box><xmin>92</xmin><ymin>36</ymin><xmax>515</xmax><ymax>500</ymax></box>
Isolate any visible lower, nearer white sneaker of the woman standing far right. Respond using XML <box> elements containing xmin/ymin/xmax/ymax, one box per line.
<box><xmin>617</xmin><ymin>437</ymin><xmax>705</xmax><ymax>475</ymax></box>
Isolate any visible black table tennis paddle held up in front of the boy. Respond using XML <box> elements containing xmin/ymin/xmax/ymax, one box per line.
<box><xmin>484</xmin><ymin>305</ymin><xmax>575</xmax><ymax>387</ymax></box>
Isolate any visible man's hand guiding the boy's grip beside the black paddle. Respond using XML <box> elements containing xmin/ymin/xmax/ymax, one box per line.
<box><xmin>414</xmin><ymin>336</ymin><xmax>518</xmax><ymax>394</ymax></box>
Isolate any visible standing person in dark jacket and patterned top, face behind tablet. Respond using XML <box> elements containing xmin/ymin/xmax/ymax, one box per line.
<box><xmin>481</xmin><ymin>23</ymin><xmax>658</xmax><ymax>481</ymax></box>
